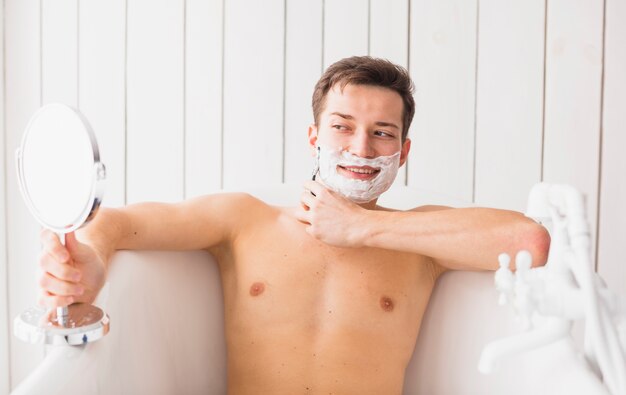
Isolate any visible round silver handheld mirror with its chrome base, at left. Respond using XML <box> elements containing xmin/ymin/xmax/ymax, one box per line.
<box><xmin>14</xmin><ymin>104</ymin><xmax>109</xmax><ymax>345</ymax></box>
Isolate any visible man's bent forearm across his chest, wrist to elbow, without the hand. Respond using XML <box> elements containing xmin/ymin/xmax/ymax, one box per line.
<box><xmin>362</xmin><ymin>206</ymin><xmax>550</xmax><ymax>270</ymax></box>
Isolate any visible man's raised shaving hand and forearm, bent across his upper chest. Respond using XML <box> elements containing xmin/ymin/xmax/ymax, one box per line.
<box><xmin>299</xmin><ymin>183</ymin><xmax>550</xmax><ymax>270</ymax></box>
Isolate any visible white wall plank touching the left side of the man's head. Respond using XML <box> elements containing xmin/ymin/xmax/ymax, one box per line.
<box><xmin>284</xmin><ymin>0</ymin><xmax>323</xmax><ymax>185</ymax></box>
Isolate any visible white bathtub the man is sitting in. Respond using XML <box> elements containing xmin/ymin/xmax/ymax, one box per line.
<box><xmin>9</xmin><ymin>186</ymin><xmax>588</xmax><ymax>395</ymax></box>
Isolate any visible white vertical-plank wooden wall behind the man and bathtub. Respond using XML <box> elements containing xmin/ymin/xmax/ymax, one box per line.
<box><xmin>0</xmin><ymin>0</ymin><xmax>626</xmax><ymax>394</ymax></box>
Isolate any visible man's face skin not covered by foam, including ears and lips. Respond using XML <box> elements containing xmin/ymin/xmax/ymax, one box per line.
<box><xmin>309</xmin><ymin>84</ymin><xmax>411</xmax><ymax>180</ymax></box>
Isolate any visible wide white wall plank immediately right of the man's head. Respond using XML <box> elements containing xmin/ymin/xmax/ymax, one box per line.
<box><xmin>407</xmin><ymin>0</ymin><xmax>477</xmax><ymax>202</ymax></box>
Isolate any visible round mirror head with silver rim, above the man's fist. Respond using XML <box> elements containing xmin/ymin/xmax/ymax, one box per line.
<box><xmin>17</xmin><ymin>104</ymin><xmax>105</xmax><ymax>233</ymax></box>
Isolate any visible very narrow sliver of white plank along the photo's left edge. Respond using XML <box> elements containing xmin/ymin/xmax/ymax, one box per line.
<box><xmin>0</xmin><ymin>2</ymin><xmax>11</xmax><ymax>394</ymax></box>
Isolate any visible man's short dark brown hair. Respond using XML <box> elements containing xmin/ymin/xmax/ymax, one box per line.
<box><xmin>312</xmin><ymin>56</ymin><xmax>415</xmax><ymax>142</ymax></box>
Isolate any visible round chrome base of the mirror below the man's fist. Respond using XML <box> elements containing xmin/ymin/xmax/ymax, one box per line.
<box><xmin>13</xmin><ymin>303</ymin><xmax>109</xmax><ymax>346</ymax></box>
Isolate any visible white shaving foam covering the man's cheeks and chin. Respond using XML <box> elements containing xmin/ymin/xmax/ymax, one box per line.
<box><xmin>319</xmin><ymin>147</ymin><xmax>400</xmax><ymax>203</ymax></box>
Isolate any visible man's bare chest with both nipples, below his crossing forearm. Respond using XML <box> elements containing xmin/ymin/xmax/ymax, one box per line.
<box><xmin>217</xmin><ymin>215</ymin><xmax>433</xmax><ymax>335</ymax></box>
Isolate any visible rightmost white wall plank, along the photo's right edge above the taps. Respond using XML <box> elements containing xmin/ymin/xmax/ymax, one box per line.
<box><xmin>598</xmin><ymin>0</ymin><xmax>626</xmax><ymax>297</ymax></box>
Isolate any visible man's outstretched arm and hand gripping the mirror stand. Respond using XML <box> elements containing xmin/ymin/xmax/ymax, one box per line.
<box><xmin>39</xmin><ymin>194</ymin><xmax>251</xmax><ymax>307</ymax></box>
